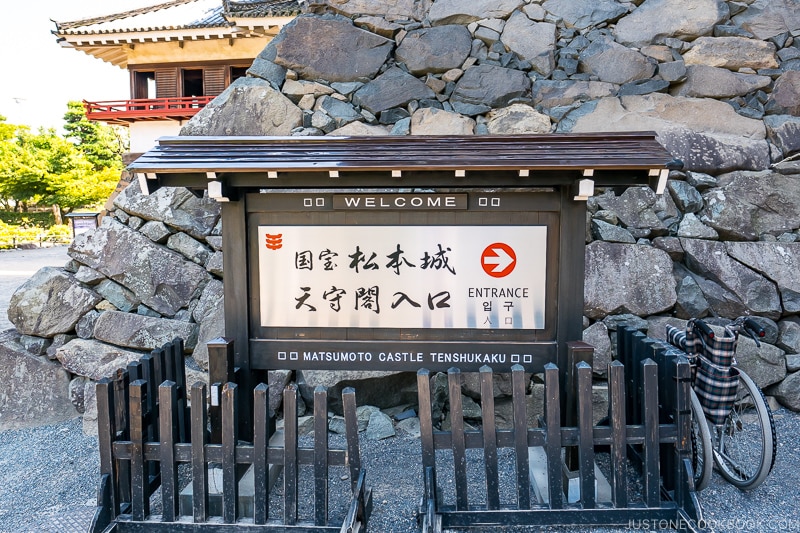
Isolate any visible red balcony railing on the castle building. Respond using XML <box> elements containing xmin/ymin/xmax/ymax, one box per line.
<box><xmin>83</xmin><ymin>96</ymin><xmax>214</xmax><ymax>124</ymax></box>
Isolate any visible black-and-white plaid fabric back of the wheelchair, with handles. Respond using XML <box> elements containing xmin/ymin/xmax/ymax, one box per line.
<box><xmin>667</xmin><ymin>320</ymin><xmax>739</xmax><ymax>425</ymax></box>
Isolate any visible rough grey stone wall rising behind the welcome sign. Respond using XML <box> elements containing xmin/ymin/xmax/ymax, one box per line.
<box><xmin>1</xmin><ymin>0</ymin><xmax>800</xmax><ymax>428</ymax></box>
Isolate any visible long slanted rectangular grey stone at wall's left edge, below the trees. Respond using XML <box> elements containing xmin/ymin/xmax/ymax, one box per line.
<box><xmin>69</xmin><ymin>217</ymin><xmax>209</xmax><ymax>316</ymax></box>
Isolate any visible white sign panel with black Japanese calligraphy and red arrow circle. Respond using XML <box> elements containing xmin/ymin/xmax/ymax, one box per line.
<box><xmin>258</xmin><ymin>226</ymin><xmax>547</xmax><ymax>329</ymax></box>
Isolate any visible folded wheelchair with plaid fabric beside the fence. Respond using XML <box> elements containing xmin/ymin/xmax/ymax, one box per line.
<box><xmin>667</xmin><ymin>317</ymin><xmax>777</xmax><ymax>490</ymax></box>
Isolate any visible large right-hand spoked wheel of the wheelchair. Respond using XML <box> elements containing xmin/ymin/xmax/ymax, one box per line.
<box><xmin>713</xmin><ymin>370</ymin><xmax>777</xmax><ymax>490</ymax></box>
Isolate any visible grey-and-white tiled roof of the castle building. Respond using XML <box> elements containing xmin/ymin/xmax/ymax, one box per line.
<box><xmin>54</xmin><ymin>0</ymin><xmax>300</xmax><ymax>36</ymax></box>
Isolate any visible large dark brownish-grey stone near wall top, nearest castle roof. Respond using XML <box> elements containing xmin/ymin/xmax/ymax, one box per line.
<box><xmin>270</xmin><ymin>16</ymin><xmax>394</xmax><ymax>82</ymax></box>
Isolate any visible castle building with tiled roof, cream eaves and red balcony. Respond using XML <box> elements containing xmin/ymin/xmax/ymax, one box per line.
<box><xmin>52</xmin><ymin>0</ymin><xmax>299</xmax><ymax>153</ymax></box>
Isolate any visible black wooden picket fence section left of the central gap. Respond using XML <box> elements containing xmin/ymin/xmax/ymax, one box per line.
<box><xmin>91</xmin><ymin>340</ymin><xmax>371</xmax><ymax>533</ymax></box>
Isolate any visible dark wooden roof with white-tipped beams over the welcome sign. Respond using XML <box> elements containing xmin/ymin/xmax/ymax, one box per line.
<box><xmin>128</xmin><ymin>132</ymin><xmax>680</xmax><ymax>193</ymax></box>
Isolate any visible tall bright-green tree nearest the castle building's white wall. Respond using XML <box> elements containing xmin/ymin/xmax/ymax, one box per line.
<box><xmin>64</xmin><ymin>102</ymin><xmax>127</xmax><ymax>170</ymax></box>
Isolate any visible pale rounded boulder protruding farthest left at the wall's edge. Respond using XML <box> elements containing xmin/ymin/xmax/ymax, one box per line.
<box><xmin>8</xmin><ymin>266</ymin><xmax>102</xmax><ymax>338</ymax></box>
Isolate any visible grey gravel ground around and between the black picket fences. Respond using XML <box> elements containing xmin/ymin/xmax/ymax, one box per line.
<box><xmin>0</xmin><ymin>409</ymin><xmax>800</xmax><ymax>533</ymax></box>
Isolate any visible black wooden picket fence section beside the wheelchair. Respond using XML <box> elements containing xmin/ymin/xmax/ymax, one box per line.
<box><xmin>417</xmin><ymin>341</ymin><xmax>701</xmax><ymax>533</ymax></box>
